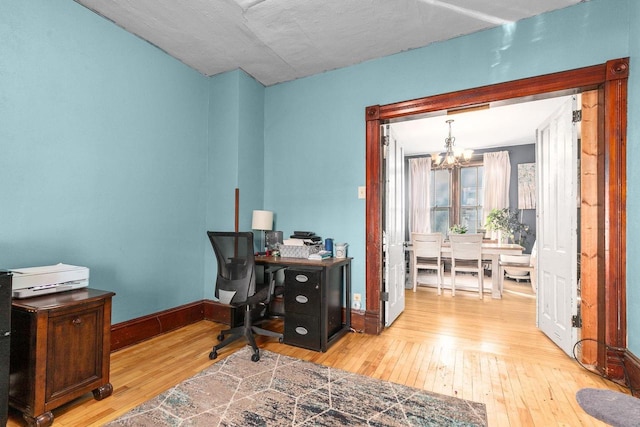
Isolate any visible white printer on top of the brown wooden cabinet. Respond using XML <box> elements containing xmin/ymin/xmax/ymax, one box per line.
<box><xmin>10</xmin><ymin>263</ymin><xmax>89</xmax><ymax>298</ymax></box>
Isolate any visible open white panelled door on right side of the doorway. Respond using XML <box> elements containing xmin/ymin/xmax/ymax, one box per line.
<box><xmin>536</xmin><ymin>97</ymin><xmax>579</xmax><ymax>356</ymax></box>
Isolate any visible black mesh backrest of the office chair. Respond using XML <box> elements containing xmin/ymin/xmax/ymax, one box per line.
<box><xmin>207</xmin><ymin>231</ymin><xmax>256</xmax><ymax>305</ymax></box>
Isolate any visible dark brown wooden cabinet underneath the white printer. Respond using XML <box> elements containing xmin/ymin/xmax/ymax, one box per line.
<box><xmin>9</xmin><ymin>288</ymin><xmax>114</xmax><ymax>426</ymax></box>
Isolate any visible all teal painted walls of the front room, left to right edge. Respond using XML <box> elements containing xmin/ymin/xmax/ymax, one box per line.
<box><xmin>0</xmin><ymin>0</ymin><xmax>640</xmax><ymax>354</ymax></box>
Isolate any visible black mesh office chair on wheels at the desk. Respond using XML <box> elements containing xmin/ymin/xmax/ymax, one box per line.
<box><xmin>207</xmin><ymin>231</ymin><xmax>283</xmax><ymax>362</ymax></box>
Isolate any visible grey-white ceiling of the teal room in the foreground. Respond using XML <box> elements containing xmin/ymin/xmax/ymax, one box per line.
<box><xmin>76</xmin><ymin>0</ymin><xmax>584</xmax><ymax>86</ymax></box>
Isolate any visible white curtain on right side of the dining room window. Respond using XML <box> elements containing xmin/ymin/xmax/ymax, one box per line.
<box><xmin>482</xmin><ymin>151</ymin><xmax>511</xmax><ymax>222</ymax></box>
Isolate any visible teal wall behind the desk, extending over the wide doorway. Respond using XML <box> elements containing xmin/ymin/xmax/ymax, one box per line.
<box><xmin>265</xmin><ymin>0</ymin><xmax>635</xmax><ymax>324</ymax></box>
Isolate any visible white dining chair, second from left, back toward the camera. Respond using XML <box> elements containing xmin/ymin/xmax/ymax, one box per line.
<box><xmin>449</xmin><ymin>234</ymin><xmax>484</xmax><ymax>299</ymax></box>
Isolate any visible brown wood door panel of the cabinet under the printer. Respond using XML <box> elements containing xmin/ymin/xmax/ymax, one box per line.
<box><xmin>45</xmin><ymin>305</ymin><xmax>104</xmax><ymax>403</ymax></box>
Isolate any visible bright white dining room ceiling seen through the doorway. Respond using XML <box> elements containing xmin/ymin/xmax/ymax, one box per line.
<box><xmin>390</xmin><ymin>96</ymin><xmax>570</xmax><ymax>155</ymax></box>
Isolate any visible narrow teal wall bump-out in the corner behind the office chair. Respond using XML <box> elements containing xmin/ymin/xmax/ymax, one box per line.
<box><xmin>202</xmin><ymin>70</ymin><xmax>264</xmax><ymax>292</ymax></box>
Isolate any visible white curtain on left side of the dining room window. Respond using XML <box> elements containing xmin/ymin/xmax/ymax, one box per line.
<box><xmin>409</xmin><ymin>157</ymin><xmax>431</xmax><ymax>233</ymax></box>
